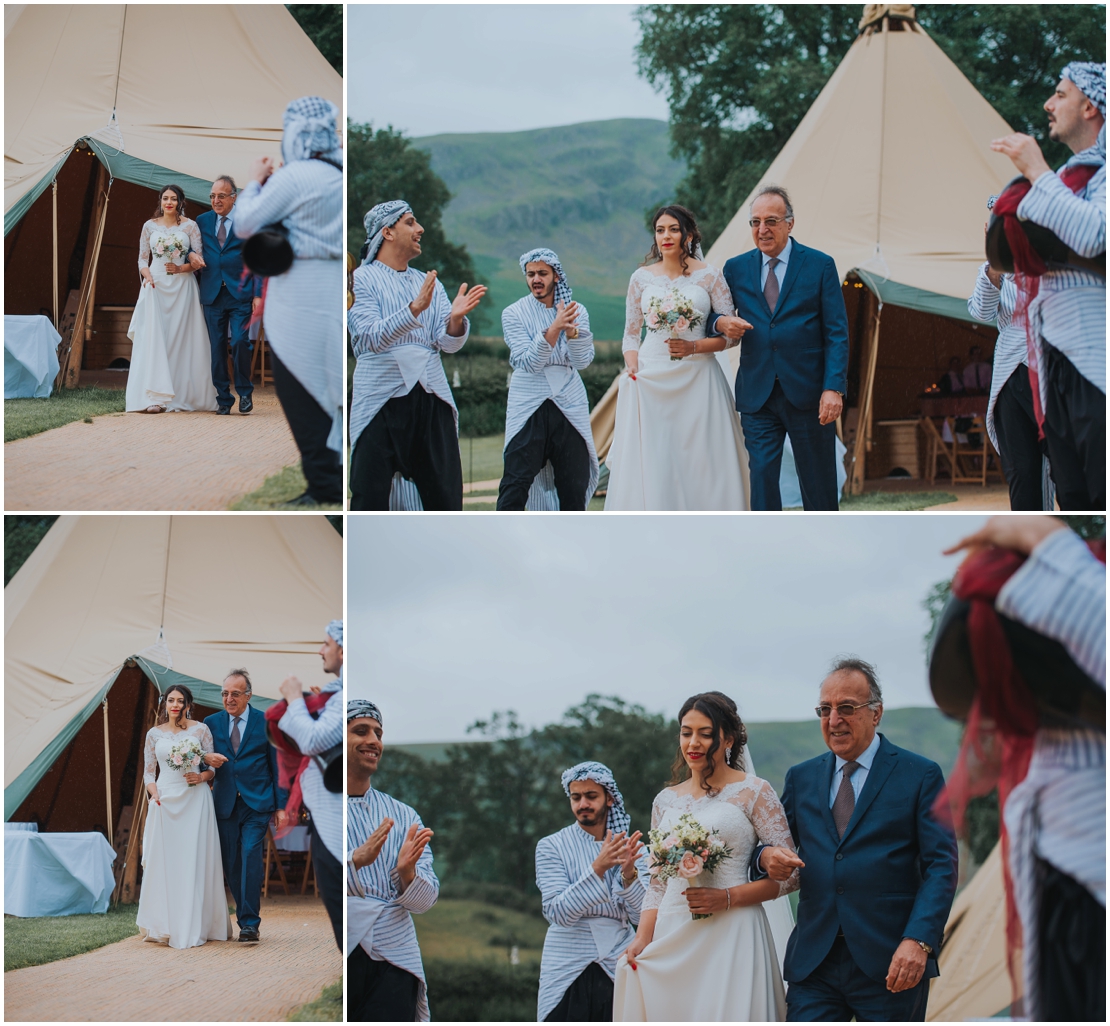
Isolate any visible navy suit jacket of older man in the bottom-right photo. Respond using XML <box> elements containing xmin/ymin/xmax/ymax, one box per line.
<box><xmin>768</xmin><ymin>734</ymin><xmax>957</xmax><ymax>983</ymax></box>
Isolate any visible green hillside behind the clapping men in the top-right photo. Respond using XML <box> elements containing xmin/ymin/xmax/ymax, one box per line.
<box><xmin>413</xmin><ymin>118</ymin><xmax>685</xmax><ymax>339</ymax></box>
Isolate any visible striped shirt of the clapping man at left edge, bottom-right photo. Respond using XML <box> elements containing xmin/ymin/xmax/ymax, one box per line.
<box><xmin>346</xmin><ymin>787</ymin><xmax>440</xmax><ymax>1023</ymax></box>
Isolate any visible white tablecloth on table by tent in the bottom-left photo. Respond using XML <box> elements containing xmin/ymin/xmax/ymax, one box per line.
<box><xmin>3</xmin><ymin>831</ymin><xmax>115</xmax><ymax>918</ymax></box>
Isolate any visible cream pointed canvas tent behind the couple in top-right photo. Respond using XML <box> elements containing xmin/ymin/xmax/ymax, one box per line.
<box><xmin>592</xmin><ymin>4</ymin><xmax>1015</xmax><ymax>490</ymax></box>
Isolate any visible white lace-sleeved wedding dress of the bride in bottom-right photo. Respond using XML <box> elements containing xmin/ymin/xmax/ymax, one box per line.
<box><xmin>613</xmin><ymin>774</ymin><xmax>797</xmax><ymax>1023</ymax></box>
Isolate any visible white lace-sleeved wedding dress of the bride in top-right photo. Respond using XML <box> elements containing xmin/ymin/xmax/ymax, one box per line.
<box><xmin>605</xmin><ymin>264</ymin><xmax>749</xmax><ymax>510</ymax></box>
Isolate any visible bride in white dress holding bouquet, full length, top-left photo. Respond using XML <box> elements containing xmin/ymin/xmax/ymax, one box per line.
<box><xmin>125</xmin><ymin>185</ymin><xmax>216</xmax><ymax>413</ymax></box>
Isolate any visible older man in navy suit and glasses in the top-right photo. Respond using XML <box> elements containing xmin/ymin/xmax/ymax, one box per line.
<box><xmin>709</xmin><ymin>185</ymin><xmax>848</xmax><ymax>510</ymax></box>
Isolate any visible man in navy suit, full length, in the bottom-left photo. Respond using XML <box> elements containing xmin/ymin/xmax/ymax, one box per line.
<box><xmin>204</xmin><ymin>670</ymin><xmax>283</xmax><ymax>943</ymax></box>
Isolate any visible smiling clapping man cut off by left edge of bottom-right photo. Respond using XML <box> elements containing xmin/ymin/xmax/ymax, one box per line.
<box><xmin>346</xmin><ymin>698</ymin><xmax>440</xmax><ymax>1023</ymax></box>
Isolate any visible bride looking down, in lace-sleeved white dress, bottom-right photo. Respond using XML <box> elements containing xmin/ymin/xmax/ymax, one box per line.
<box><xmin>613</xmin><ymin>692</ymin><xmax>798</xmax><ymax>1023</ymax></box>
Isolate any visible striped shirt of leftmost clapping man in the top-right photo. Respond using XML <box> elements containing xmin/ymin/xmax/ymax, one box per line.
<box><xmin>347</xmin><ymin>260</ymin><xmax>471</xmax><ymax>450</ymax></box>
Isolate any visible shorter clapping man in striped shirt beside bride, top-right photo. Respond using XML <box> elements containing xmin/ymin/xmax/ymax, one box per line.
<box><xmin>497</xmin><ymin>249</ymin><xmax>598</xmax><ymax>510</ymax></box>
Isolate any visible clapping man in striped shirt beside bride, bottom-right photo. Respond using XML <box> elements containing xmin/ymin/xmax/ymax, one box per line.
<box><xmin>536</xmin><ymin>762</ymin><xmax>647</xmax><ymax>1023</ymax></box>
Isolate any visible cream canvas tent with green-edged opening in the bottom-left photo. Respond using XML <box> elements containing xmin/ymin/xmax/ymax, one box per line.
<box><xmin>4</xmin><ymin>515</ymin><xmax>343</xmax><ymax>857</ymax></box>
